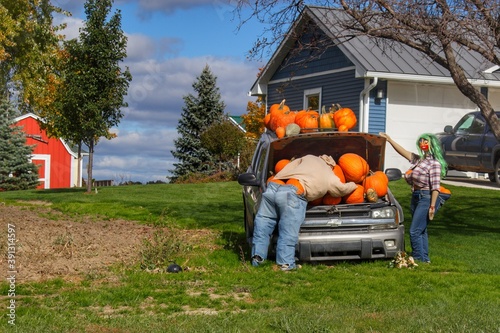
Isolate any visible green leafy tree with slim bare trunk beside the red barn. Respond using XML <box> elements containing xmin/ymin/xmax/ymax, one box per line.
<box><xmin>46</xmin><ymin>0</ymin><xmax>132</xmax><ymax>192</ymax></box>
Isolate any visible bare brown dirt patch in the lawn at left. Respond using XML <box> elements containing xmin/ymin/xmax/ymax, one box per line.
<box><xmin>0</xmin><ymin>205</ymin><xmax>216</xmax><ymax>282</ymax></box>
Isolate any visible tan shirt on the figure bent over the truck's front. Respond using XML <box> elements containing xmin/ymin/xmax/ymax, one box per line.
<box><xmin>275</xmin><ymin>155</ymin><xmax>356</xmax><ymax>201</ymax></box>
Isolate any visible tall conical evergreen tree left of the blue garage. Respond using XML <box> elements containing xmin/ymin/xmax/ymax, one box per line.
<box><xmin>170</xmin><ymin>65</ymin><xmax>225</xmax><ymax>182</ymax></box>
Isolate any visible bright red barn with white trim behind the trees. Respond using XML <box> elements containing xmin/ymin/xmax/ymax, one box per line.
<box><xmin>14</xmin><ymin>113</ymin><xmax>87</xmax><ymax>189</ymax></box>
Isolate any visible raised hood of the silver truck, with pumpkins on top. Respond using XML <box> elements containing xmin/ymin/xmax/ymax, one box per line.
<box><xmin>269</xmin><ymin>132</ymin><xmax>386</xmax><ymax>171</ymax></box>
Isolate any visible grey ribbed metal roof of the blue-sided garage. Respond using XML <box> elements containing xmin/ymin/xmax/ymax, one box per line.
<box><xmin>251</xmin><ymin>6</ymin><xmax>500</xmax><ymax>94</ymax></box>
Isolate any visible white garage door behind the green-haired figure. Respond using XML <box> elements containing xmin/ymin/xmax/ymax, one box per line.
<box><xmin>385</xmin><ymin>81</ymin><xmax>476</xmax><ymax>171</ymax></box>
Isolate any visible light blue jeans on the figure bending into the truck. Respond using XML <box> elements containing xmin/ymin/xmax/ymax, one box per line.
<box><xmin>252</xmin><ymin>182</ymin><xmax>307</xmax><ymax>268</ymax></box>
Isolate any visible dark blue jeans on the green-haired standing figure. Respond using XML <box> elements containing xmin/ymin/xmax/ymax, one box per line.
<box><xmin>410</xmin><ymin>190</ymin><xmax>444</xmax><ymax>262</ymax></box>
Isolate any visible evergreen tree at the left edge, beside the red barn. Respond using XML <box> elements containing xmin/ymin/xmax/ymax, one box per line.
<box><xmin>0</xmin><ymin>100</ymin><xmax>38</xmax><ymax>191</ymax></box>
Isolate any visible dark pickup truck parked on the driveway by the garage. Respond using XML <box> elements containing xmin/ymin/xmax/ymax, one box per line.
<box><xmin>436</xmin><ymin>111</ymin><xmax>500</xmax><ymax>185</ymax></box>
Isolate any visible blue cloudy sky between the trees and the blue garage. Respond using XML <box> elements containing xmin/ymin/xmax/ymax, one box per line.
<box><xmin>53</xmin><ymin>0</ymin><xmax>265</xmax><ymax>183</ymax></box>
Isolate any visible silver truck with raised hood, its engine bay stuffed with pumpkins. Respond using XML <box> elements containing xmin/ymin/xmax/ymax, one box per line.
<box><xmin>238</xmin><ymin>131</ymin><xmax>405</xmax><ymax>262</ymax></box>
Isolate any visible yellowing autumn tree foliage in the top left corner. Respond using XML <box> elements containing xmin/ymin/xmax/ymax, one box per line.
<box><xmin>0</xmin><ymin>0</ymin><xmax>64</xmax><ymax>116</ymax></box>
